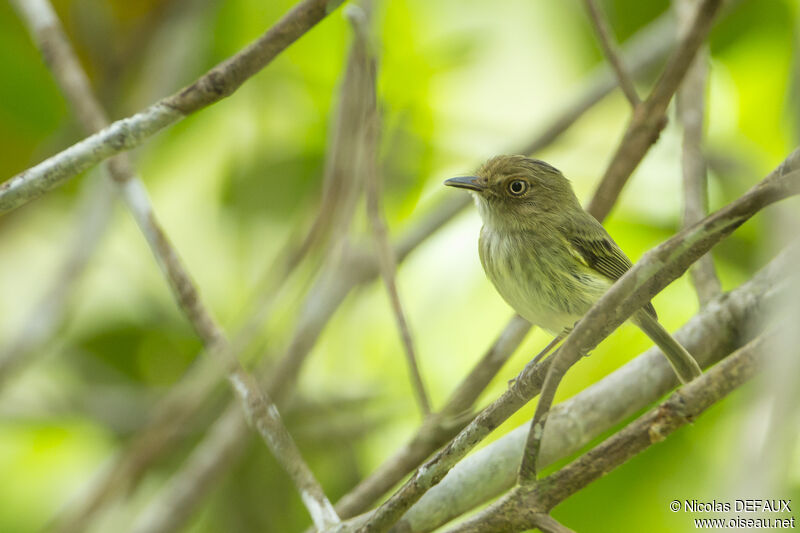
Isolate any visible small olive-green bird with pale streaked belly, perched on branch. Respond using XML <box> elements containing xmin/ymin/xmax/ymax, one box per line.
<box><xmin>445</xmin><ymin>155</ymin><xmax>701</xmax><ymax>383</ymax></box>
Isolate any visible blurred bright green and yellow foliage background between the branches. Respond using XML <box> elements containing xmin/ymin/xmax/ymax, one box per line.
<box><xmin>0</xmin><ymin>0</ymin><xmax>800</xmax><ymax>532</ymax></box>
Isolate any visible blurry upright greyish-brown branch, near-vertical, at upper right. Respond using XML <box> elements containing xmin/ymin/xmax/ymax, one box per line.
<box><xmin>675</xmin><ymin>0</ymin><xmax>722</xmax><ymax>305</ymax></box>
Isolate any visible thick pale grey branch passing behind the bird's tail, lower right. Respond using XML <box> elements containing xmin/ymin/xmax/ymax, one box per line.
<box><xmin>388</xmin><ymin>245</ymin><xmax>800</xmax><ymax>533</ymax></box>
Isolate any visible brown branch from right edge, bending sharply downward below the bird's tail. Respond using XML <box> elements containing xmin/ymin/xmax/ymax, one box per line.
<box><xmin>520</xmin><ymin>148</ymin><xmax>800</xmax><ymax>483</ymax></box>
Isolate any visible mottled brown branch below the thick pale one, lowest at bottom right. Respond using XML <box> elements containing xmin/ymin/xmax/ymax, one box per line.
<box><xmin>448</xmin><ymin>333</ymin><xmax>772</xmax><ymax>533</ymax></box>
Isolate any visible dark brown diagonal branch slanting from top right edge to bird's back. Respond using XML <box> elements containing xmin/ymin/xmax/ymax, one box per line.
<box><xmin>586</xmin><ymin>0</ymin><xmax>722</xmax><ymax>222</ymax></box>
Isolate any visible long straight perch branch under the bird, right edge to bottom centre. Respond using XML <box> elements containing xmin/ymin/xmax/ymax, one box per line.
<box><xmin>342</xmin><ymin>149</ymin><xmax>800</xmax><ymax>533</ymax></box>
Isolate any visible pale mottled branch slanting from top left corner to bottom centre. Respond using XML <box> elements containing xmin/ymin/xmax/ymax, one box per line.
<box><xmin>10</xmin><ymin>0</ymin><xmax>339</xmax><ymax>527</ymax></box>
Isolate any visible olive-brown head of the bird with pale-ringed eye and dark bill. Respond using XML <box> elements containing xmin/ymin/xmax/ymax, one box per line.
<box><xmin>444</xmin><ymin>155</ymin><xmax>580</xmax><ymax>230</ymax></box>
